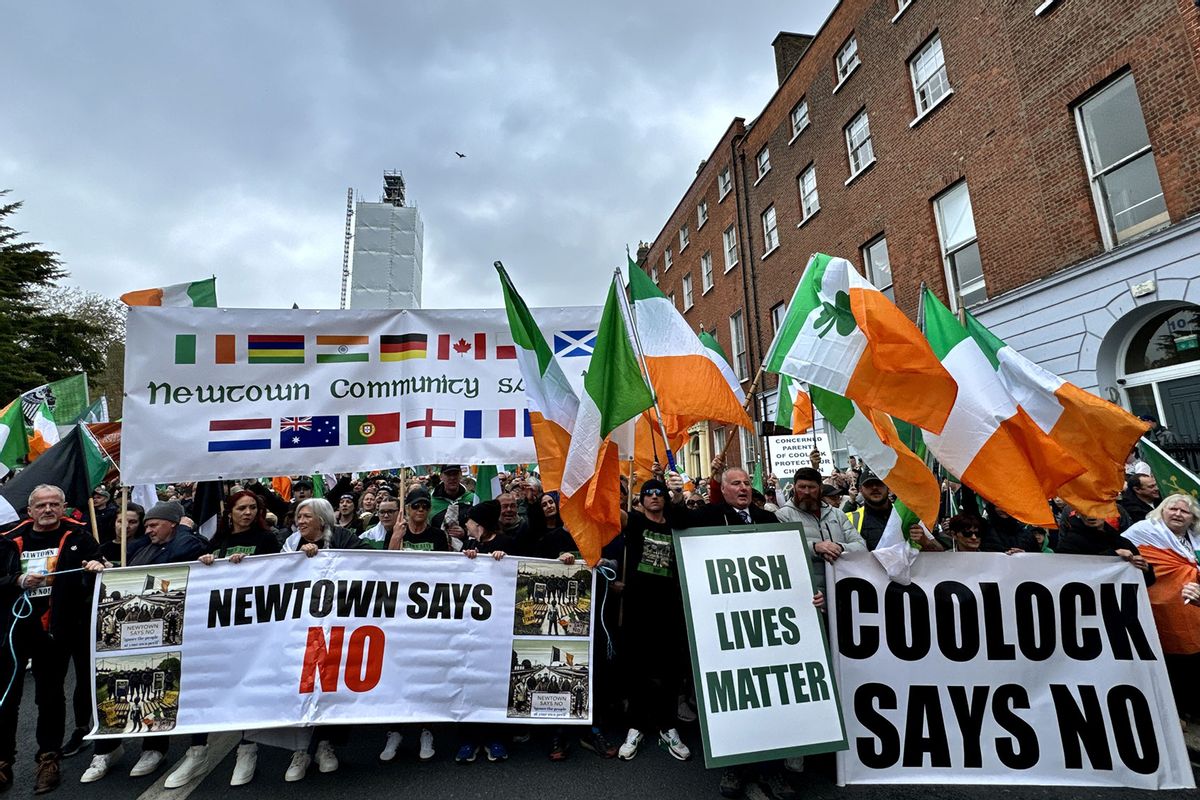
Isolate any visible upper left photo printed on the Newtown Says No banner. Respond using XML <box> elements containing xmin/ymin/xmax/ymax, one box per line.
<box><xmin>96</xmin><ymin>565</ymin><xmax>190</xmax><ymax>652</ymax></box>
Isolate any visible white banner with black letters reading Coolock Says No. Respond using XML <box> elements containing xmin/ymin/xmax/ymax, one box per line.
<box><xmin>828</xmin><ymin>553</ymin><xmax>1194</xmax><ymax>789</ymax></box>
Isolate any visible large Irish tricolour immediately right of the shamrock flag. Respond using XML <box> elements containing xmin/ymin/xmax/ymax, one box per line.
<box><xmin>910</xmin><ymin>289</ymin><xmax>1084</xmax><ymax>528</ymax></box>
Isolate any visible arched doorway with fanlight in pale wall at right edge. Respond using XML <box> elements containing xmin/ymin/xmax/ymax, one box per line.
<box><xmin>1117</xmin><ymin>303</ymin><xmax>1200</xmax><ymax>443</ymax></box>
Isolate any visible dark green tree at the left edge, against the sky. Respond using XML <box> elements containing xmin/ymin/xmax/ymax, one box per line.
<box><xmin>0</xmin><ymin>191</ymin><xmax>104</xmax><ymax>403</ymax></box>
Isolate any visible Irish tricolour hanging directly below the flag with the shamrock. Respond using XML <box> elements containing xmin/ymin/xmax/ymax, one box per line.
<box><xmin>809</xmin><ymin>386</ymin><xmax>941</xmax><ymax>525</ymax></box>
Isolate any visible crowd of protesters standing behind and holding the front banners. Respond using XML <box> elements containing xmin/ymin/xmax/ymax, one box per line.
<box><xmin>0</xmin><ymin>452</ymin><xmax>1200</xmax><ymax>800</ymax></box>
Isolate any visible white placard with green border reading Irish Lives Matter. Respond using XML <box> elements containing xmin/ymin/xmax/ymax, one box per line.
<box><xmin>674</xmin><ymin>525</ymin><xmax>846</xmax><ymax>768</ymax></box>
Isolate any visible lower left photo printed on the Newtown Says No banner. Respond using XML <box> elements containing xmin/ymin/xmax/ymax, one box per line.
<box><xmin>96</xmin><ymin>650</ymin><xmax>182</xmax><ymax>735</ymax></box>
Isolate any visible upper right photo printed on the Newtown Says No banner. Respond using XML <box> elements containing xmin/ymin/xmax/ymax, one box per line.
<box><xmin>512</xmin><ymin>560</ymin><xmax>592</xmax><ymax>636</ymax></box>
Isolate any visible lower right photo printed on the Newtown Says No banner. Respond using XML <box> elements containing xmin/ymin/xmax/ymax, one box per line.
<box><xmin>509</xmin><ymin>639</ymin><xmax>590</xmax><ymax>720</ymax></box>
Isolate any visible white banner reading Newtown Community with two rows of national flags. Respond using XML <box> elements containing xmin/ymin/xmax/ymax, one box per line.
<box><xmin>121</xmin><ymin>306</ymin><xmax>600</xmax><ymax>483</ymax></box>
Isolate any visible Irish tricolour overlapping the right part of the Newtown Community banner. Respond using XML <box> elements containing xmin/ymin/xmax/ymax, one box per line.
<box><xmin>496</xmin><ymin>264</ymin><xmax>580</xmax><ymax>492</ymax></box>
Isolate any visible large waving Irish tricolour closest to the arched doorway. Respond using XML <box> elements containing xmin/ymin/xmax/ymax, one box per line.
<box><xmin>966</xmin><ymin>312</ymin><xmax>1150</xmax><ymax>518</ymax></box>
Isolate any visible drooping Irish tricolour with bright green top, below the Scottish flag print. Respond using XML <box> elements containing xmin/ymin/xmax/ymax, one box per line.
<box><xmin>556</xmin><ymin>278</ymin><xmax>653</xmax><ymax>565</ymax></box>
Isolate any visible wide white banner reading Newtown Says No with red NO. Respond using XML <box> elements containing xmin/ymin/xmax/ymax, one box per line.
<box><xmin>92</xmin><ymin>551</ymin><xmax>594</xmax><ymax>738</ymax></box>
